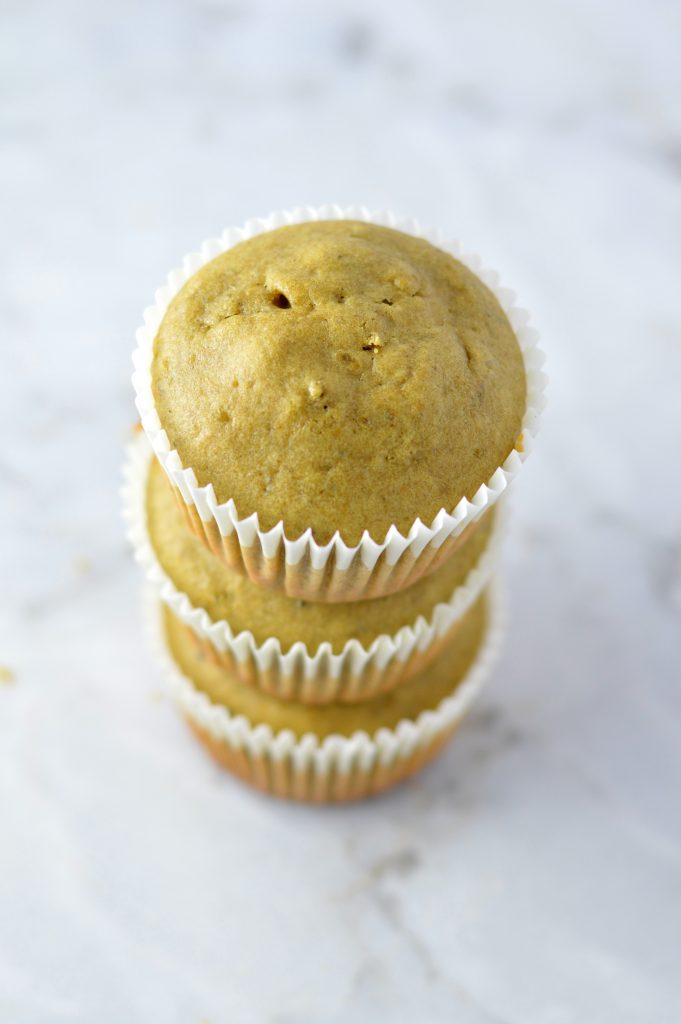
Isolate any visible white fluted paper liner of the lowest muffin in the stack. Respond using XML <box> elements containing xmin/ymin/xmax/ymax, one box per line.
<box><xmin>144</xmin><ymin>583</ymin><xmax>506</xmax><ymax>803</ymax></box>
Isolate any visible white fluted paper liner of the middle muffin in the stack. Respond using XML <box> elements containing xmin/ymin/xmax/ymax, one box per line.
<box><xmin>122</xmin><ymin>434</ymin><xmax>506</xmax><ymax>703</ymax></box>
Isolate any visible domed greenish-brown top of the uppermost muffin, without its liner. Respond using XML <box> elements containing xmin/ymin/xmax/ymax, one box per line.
<box><xmin>152</xmin><ymin>220</ymin><xmax>525</xmax><ymax>545</ymax></box>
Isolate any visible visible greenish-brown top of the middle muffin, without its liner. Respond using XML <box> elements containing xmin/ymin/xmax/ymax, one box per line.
<box><xmin>146</xmin><ymin>459</ymin><xmax>495</xmax><ymax>654</ymax></box>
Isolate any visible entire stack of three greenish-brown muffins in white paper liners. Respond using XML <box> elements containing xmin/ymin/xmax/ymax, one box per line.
<box><xmin>125</xmin><ymin>207</ymin><xmax>543</xmax><ymax>802</ymax></box>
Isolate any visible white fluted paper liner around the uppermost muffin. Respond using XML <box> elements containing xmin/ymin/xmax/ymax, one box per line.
<box><xmin>132</xmin><ymin>205</ymin><xmax>547</xmax><ymax>601</ymax></box>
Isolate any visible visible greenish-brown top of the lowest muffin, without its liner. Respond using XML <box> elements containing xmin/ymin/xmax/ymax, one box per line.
<box><xmin>163</xmin><ymin>594</ymin><xmax>487</xmax><ymax>737</ymax></box>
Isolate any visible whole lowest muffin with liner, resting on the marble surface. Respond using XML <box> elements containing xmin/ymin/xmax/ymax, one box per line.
<box><xmin>153</xmin><ymin>593</ymin><xmax>501</xmax><ymax>803</ymax></box>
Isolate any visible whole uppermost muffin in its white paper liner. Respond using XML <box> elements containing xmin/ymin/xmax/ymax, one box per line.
<box><xmin>130</xmin><ymin>211</ymin><xmax>537</xmax><ymax>601</ymax></box>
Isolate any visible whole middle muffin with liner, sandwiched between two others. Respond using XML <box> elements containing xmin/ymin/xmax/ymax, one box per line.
<box><xmin>128</xmin><ymin>439</ymin><xmax>503</xmax><ymax>703</ymax></box>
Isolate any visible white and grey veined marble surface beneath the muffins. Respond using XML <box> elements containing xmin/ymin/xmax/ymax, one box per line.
<box><xmin>0</xmin><ymin>0</ymin><xmax>681</xmax><ymax>1024</ymax></box>
